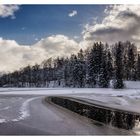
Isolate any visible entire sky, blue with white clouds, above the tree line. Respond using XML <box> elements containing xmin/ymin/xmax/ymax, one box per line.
<box><xmin>0</xmin><ymin>5</ymin><xmax>140</xmax><ymax>72</ymax></box>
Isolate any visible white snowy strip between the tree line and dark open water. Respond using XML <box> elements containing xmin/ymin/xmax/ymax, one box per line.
<box><xmin>0</xmin><ymin>81</ymin><xmax>140</xmax><ymax>113</ymax></box>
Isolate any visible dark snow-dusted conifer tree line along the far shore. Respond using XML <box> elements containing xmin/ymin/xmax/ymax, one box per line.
<box><xmin>0</xmin><ymin>41</ymin><xmax>140</xmax><ymax>88</ymax></box>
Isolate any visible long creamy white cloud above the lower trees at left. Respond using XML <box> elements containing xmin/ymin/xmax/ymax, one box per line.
<box><xmin>0</xmin><ymin>35</ymin><xmax>79</xmax><ymax>71</ymax></box>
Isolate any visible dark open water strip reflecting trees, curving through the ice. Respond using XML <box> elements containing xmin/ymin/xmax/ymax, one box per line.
<box><xmin>49</xmin><ymin>97</ymin><xmax>140</xmax><ymax>130</ymax></box>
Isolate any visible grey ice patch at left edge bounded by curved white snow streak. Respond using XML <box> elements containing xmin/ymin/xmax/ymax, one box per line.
<box><xmin>0</xmin><ymin>96</ymin><xmax>40</xmax><ymax>123</ymax></box>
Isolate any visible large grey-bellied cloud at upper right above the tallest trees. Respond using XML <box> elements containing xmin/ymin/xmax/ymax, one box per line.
<box><xmin>82</xmin><ymin>5</ymin><xmax>140</xmax><ymax>48</ymax></box>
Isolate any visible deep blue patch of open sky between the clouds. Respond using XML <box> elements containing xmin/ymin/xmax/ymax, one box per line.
<box><xmin>0</xmin><ymin>5</ymin><xmax>105</xmax><ymax>45</ymax></box>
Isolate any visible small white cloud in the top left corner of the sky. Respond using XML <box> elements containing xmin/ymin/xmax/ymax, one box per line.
<box><xmin>0</xmin><ymin>5</ymin><xmax>19</xmax><ymax>19</ymax></box>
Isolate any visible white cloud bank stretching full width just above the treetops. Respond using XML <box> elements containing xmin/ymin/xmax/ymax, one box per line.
<box><xmin>0</xmin><ymin>5</ymin><xmax>140</xmax><ymax>71</ymax></box>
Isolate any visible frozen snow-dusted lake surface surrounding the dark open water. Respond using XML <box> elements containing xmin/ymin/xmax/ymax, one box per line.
<box><xmin>0</xmin><ymin>88</ymin><xmax>139</xmax><ymax>135</ymax></box>
